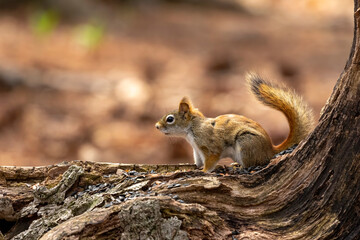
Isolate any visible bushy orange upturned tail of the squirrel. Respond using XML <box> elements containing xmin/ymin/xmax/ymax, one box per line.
<box><xmin>247</xmin><ymin>73</ymin><xmax>313</xmax><ymax>152</ymax></box>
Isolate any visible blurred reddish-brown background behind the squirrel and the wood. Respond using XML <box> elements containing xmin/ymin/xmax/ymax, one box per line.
<box><xmin>0</xmin><ymin>0</ymin><xmax>353</xmax><ymax>166</ymax></box>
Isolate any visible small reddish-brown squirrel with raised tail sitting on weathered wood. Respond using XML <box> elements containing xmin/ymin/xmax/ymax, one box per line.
<box><xmin>155</xmin><ymin>74</ymin><xmax>313</xmax><ymax>172</ymax></box>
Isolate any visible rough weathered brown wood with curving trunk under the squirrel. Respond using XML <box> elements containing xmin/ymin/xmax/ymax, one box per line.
<box><xmin>0</xmin><ymin>0</ymin><xmax>360</xmax><ymax>239</ymax></box>
